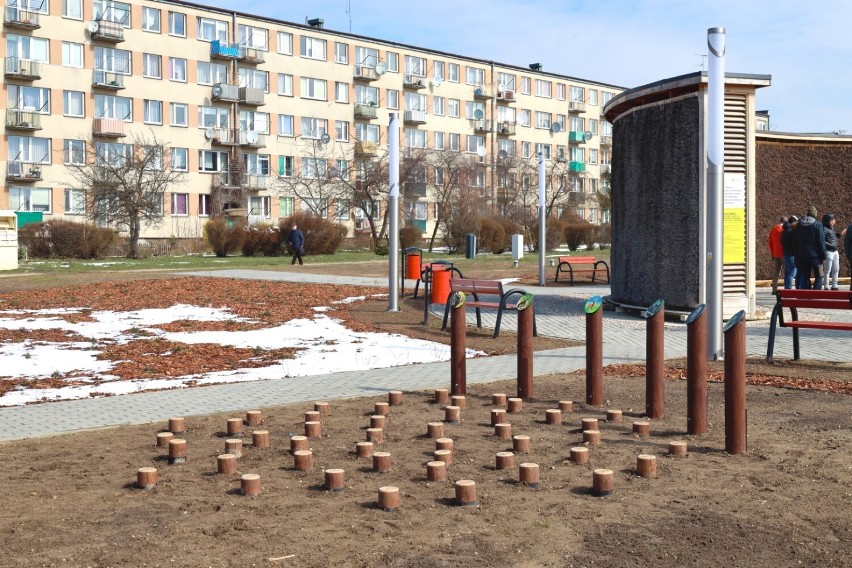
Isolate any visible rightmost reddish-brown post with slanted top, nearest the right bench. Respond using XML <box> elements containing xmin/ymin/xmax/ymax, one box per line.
<box><xmin>723</xmin><ymin>310</ymin><xmax>747</xmax><ymax>454</ymax></box>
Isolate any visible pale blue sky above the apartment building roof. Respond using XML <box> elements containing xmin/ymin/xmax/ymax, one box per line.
<box><xmin>205</xmin><ymin>0</ymin><xmax>852</xmax><ymax>135</ymax></box>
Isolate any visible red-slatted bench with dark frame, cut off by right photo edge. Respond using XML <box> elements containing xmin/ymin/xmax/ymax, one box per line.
<box><xmin>766</xmin><ymin>289</ymin><xmax>852</xmax><ymax>363</ymax></box>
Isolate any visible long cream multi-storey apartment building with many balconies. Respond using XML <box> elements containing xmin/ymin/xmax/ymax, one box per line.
<box><xmin>0</xmin><ymin>0</ymin><xmax>623</xmax><ymax>238</ymax></box>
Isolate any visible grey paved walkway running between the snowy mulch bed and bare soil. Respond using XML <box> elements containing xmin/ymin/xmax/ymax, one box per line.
<box><xmin>0</xmin><ymin>270</ymin><xmax>852</xmax><ymax>441</ymax></box>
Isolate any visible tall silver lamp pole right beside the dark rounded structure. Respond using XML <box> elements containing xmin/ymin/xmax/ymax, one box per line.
<box><xmin>707</xmin><ymin>28</ymin><xmax>725</xmax><ymax>361</ymax></box>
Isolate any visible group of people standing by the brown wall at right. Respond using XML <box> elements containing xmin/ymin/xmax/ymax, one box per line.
<box><xmin>769</xmin><ymin>205</ymin><xmax>852</xmax><ymax>294</ymax></box>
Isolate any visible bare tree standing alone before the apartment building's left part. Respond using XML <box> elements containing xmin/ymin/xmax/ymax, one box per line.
<box><xmin>65</xmin><ymin>132</ymin><xmax>184</xmax><ymax>258</ymax></box>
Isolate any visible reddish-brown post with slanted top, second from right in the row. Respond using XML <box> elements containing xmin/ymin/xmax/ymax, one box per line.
<box><xmin>686</xmin><ymin>304</ymin><xmax>707</xmax><ymax>435</ymax></box>
